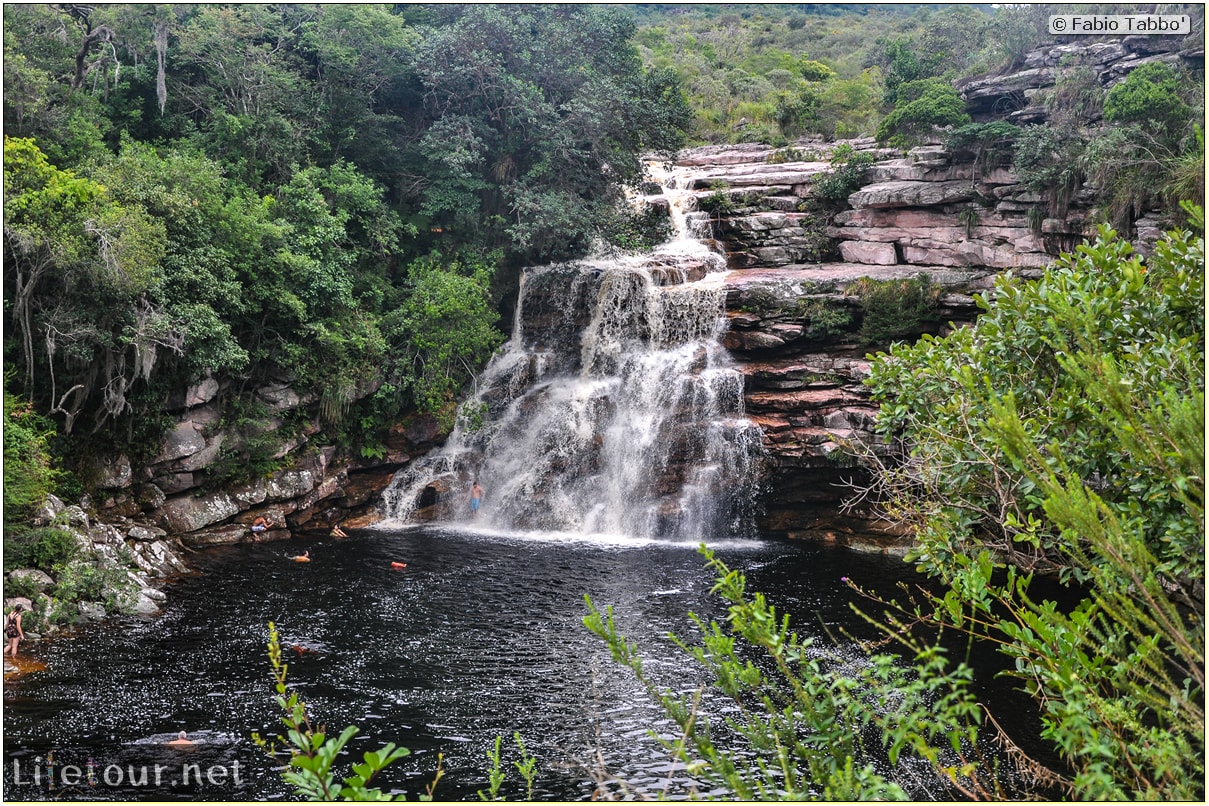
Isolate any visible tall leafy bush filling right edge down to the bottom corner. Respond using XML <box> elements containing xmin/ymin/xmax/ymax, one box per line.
<box><xmin>855</xmin><ymin>209</ymin><xmax>1205</xmax><ymax>802</ymax></box>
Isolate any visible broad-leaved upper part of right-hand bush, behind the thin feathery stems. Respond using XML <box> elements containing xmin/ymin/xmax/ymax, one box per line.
<box><xmin>869</xmin><ymin>211</ymin><xmax>1204</xmax><ymax>580</ymax></box>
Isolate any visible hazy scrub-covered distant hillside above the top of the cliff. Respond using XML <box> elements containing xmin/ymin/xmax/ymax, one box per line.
<box><xmin>626</xmin><ymin>4</ymin><xmax>1191</xmax><ymax>145</ymax></box>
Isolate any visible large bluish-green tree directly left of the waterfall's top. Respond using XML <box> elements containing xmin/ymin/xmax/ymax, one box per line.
<box><xmin>416</xmin><ymin>6</ymin><xmax>688</xmax><ymax>266</ymax></box>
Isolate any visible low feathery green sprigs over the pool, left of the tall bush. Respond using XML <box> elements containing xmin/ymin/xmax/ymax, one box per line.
<box><xmin>584</xmin><ymin>546</ymin><xmax>995</xmax><ymax>801</ymax></box>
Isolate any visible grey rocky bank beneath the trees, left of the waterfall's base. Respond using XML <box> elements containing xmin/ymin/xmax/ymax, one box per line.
<box><xmin>87</xmin><ymin>364</ymin><xmax>441</xmax><ymax>548</ymax></box>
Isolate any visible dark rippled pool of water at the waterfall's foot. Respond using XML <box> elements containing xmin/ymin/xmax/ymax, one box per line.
<box><xmin>4</xmin><ymin>528</ymin><xmax>1054</xmax><ymax>800</ymax></box>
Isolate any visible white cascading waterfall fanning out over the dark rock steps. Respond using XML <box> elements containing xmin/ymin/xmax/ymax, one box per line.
<box><xmin>383</xmin><ymin>166</ymin><xmax>763</xmax><ymax>540</ymax></box>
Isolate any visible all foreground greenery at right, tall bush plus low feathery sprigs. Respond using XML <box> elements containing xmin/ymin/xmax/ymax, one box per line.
<box><xmin>584</xmin><ymin>209</ymin><xmax>1205</xmax><ymax>802</ymax></box>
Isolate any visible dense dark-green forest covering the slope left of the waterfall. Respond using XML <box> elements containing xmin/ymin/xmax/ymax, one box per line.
<box><xmin>4</xmin><ymin>4</ymin><xmax>689</xmax><ymax>483</ymax></box>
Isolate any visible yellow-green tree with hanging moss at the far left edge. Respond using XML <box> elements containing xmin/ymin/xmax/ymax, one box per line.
<box><xmin>5</xmin><ymin>139</ymin><xmax>180</xmax><ymax>433</ymax></box>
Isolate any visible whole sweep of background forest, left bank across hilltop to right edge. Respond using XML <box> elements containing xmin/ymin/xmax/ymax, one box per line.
<box><xmin>4</xmin><ymin>4</ymin><xmax>1204</xmax><ymax>497</ymax></box>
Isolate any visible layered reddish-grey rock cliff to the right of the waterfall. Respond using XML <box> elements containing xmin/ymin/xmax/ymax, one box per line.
<box><xmin>675</xmin><ymin>29</ymin><xmax>1204</xmax><ymax>551</ymax></box>
